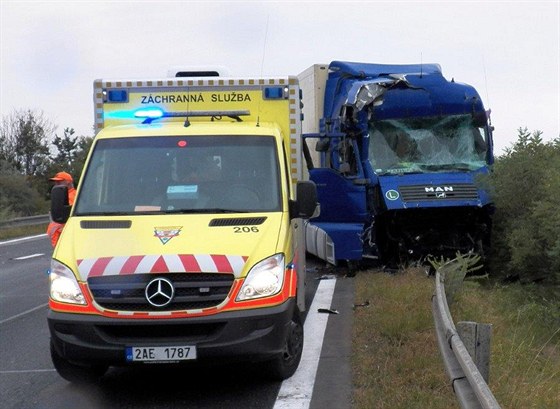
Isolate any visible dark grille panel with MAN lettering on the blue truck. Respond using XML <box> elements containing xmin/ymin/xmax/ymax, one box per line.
<box><xmin>399</xmin><ymin>183</ymin><xmax>478</xmax><ymax>202</ymax></box>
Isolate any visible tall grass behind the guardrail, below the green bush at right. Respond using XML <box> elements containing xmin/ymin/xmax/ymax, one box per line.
<box><xmin>451</xmin><ymin>282</ymin><xmax>560</xmax><ymax>409</ymax></box>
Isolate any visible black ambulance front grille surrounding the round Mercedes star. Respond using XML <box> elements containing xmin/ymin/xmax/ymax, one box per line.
<box><xmin>88</xmin><ymin>273</ymin><xmax>234</xmax><ymax>311</ymax></box>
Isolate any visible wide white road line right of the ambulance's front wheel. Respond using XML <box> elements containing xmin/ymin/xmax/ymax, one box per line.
<box><xmin>274</xmin><ymin>279</ymin><xmax>336</xmax><ymax>409</ymax></box>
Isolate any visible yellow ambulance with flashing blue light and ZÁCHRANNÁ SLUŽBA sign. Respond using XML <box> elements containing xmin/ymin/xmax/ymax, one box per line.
<box><xmin>48</xmin><ymin>74</ymin><xmax>317</xmax><ymax>382</ymax></box>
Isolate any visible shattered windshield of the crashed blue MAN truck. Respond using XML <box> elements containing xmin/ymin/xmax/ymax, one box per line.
<box><xmin>369</xmin><ymin>115</ymin><xmax>487</xmax><ymax>174</ymax></box>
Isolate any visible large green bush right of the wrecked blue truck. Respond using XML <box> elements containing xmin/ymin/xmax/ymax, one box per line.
<box><xmin>489</xmin><ymin>129</ymin><xmax>560</xmax><ymax>282</ymax></box>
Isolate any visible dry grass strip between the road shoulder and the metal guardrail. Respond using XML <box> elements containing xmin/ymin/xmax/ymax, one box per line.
<box><xmin>352</xmin><ymin>269</ymin><xmax>459</xmax><ymax>409</ymax></box>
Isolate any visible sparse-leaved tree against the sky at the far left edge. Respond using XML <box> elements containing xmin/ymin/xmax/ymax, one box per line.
<box><xmin>0</xmin><ymin>110</ymin><xmax>56</xmax><ymax>176</ymax></box>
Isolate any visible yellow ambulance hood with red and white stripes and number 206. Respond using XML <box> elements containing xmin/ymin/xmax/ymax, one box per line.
<box><xmin>58</xmin><ymin>213</ymin><xmax>290</xmax><ymax>281</ymax></box>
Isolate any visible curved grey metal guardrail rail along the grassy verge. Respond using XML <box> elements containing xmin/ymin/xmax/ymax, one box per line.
<box><xmin>432</xmin><ymin>263</ymin><xmax>500</xmax><ymax>409</ymax></box>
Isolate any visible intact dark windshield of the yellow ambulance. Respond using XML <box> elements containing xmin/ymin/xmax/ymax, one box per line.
<box><xmin>75</xmin><ymin>136</ymin><xmax>281</xmax><ymax>216</ymax></box>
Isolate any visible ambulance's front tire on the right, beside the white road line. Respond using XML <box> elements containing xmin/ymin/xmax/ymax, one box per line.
<box><xmin>264</xmin><ymin>311</ymin><xmax>303</xmax><ymax>381</ymax></box>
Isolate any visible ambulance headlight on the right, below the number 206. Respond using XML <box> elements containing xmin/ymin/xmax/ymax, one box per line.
<box><xmin>236</xmin><ymin>254</ymin><xmax>285</xmax><ymax>301</ymax></box>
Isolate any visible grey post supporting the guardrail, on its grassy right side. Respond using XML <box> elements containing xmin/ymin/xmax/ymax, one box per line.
<box><xmin>457</xmin><ymin>321</ymin><xmax>492</xmax><ymax>383</ymax></box>
